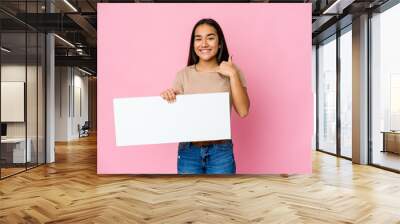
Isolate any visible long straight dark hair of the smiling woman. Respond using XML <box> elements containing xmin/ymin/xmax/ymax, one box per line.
<box><xmin>187</xmin><ymin>18</ymin><xmax>229</xmax><ymax>66</ymax></box>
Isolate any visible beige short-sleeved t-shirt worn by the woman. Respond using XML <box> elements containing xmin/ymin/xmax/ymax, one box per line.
<box><xmin>172</xmin><ymin>65</ymin><xmax>247</xmax><ymax>96</ymax></box>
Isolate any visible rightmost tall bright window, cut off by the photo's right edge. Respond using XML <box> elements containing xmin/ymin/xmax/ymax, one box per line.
<box><xmin>370</xmin><ymin>4</ymin><xmax>400</xmax><ymax>170</ymax></box>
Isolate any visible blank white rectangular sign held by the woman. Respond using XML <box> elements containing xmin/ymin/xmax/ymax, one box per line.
<box><xmin>113</xmin><ymin>92</ymin><xmax>231</xmax><ymax>146</ymax></box>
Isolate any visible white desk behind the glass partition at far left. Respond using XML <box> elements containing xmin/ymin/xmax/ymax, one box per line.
<box><xmin>1</xmin><ymin>138</ymin><xmax>32</xmax><ymax>163</ymax></box>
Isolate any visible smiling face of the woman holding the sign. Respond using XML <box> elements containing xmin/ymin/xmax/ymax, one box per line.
<box><xmin>193</xmin><ymin>24</ymin><xmax>219</xmax><ymax>62</ymax></box>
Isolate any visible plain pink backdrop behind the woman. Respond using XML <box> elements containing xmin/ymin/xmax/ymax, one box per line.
<box><xmin>97</xmin><ymin>3</ymin><xmax>313</xmax><ymax>174</ymax></box>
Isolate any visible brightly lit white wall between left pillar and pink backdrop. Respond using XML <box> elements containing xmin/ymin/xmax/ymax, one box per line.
<box><xmin>55</xmin><ymin>67</ymin><xmax>88</xmax><ymax>141</ymax></box>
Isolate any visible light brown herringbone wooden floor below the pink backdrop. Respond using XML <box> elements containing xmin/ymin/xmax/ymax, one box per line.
<box><xmin>0</xmin><ymin>134</ymin><xmax>400</xmax><ymax>224</ymax></box>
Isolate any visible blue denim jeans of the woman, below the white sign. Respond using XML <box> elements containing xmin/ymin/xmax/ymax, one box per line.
<box><xmin>178</xmin><ymin>140</ymin><xmax>236</xmax><ymax>174</ymax></box>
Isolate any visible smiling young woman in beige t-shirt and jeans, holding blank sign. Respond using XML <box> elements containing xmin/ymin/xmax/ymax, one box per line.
<box><xmin>161</xmin><ymin>19</ymin><xmax>250</xmax><ymax>174</ymax></box>
